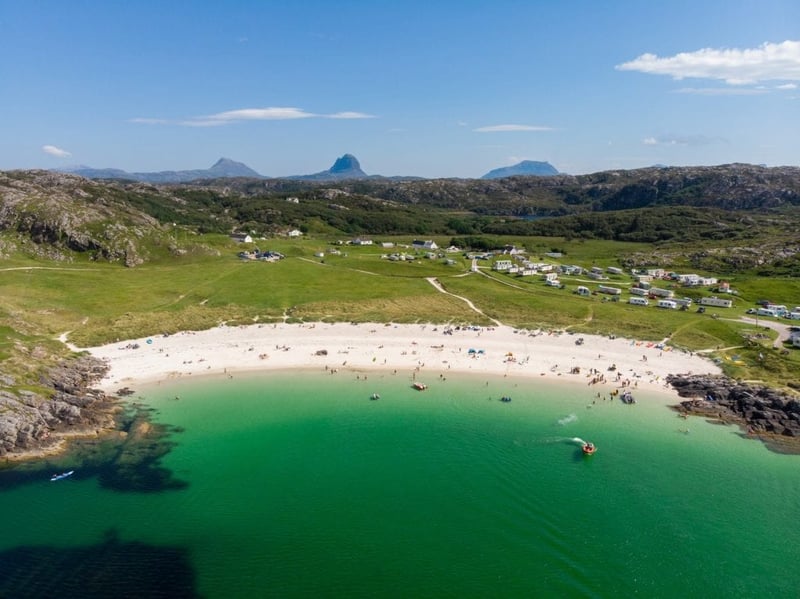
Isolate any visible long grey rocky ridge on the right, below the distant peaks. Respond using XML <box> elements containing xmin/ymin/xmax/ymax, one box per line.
<box><xmin>200</xmin><ymin>164</ymin><xmax>800</xmax><ymax>217</ymax></box>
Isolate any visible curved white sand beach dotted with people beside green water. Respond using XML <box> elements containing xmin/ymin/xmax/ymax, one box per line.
<box><xmin>88</xmin><ymin>323</ymin><xmax>720</xmax><ymax>398</ymax></box>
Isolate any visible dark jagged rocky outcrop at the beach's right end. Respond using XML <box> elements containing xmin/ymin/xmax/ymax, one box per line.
<box><xmin>667</xmin><ymin>375</ymin><xmax>800</xmax><ymax>453</ymax></box>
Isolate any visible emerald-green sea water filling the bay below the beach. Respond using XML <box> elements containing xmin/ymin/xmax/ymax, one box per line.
<box><xmin>0</xmin><ymin>372</ymin><xmax>800</xmax><ymax>597</ymax></box>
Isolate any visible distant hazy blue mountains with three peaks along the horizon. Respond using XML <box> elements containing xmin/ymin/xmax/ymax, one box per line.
<box><xmin>62</xmin><ymin>154</ymin><xmax>559</xmax><ymax>183</ymax></box>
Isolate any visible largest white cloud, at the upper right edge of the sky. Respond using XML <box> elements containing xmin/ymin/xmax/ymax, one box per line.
<box><xmin>614</xmin><ymin>40</ymin><xmax>800</xmax><ymax>85</ymax></box>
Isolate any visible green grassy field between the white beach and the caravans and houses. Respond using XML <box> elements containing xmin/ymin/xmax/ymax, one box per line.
<box><xmin>0</xmin><ymin>235</ymin><xmax>800</xmax><ymax>394</ymax></box>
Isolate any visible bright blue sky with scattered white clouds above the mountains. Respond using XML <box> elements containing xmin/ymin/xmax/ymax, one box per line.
<box><xmin>0</xmin><ymin>0</ymin><xmax>800</xmax><ymax>177</ymax></box>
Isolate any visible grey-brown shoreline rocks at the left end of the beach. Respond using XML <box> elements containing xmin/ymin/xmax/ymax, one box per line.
<box><xmin>0</xmin><ymin>356</ymin><xmax>116</xmax><ymax>456</ymax></box>
